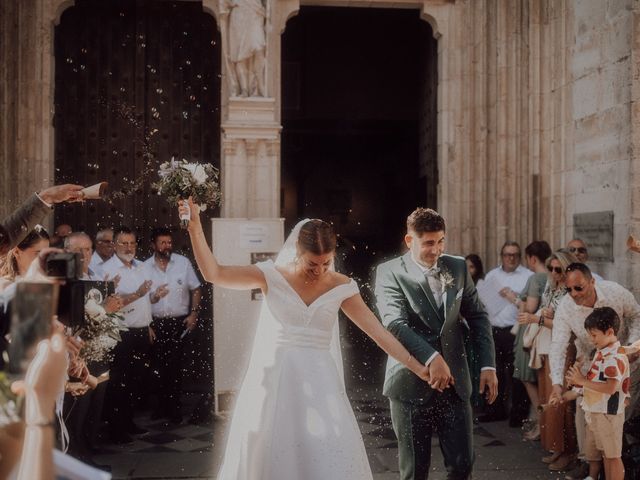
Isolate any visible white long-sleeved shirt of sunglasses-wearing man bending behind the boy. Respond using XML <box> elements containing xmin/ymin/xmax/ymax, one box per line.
<box><xmin>549</xmin><ymin>280</ymin><xmax>640</xmax><ymax>385</ymax></box>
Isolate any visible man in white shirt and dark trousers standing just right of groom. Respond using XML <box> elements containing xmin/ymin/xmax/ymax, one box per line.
<box><xmin>478</xmin><ymin>241</ymin><xmax>533</xmax><ymax>426</ymax></box>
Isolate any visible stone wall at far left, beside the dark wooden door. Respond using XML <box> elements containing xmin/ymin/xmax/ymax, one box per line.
<box><xmin>0</xmin><ymin>0</ymin><xmax>65</xmax><ymax>220</ymax></box>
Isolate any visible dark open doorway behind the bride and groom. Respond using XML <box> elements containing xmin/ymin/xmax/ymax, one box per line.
<box><xmin>282</xmin><ymin>7</ymin><xmax>438</xmax><ymax>388</ymax></box>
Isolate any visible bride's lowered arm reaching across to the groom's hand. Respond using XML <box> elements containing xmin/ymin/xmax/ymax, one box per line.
<box><xmin>342</xmin><ymin>294</ymin><xmax>429</xmax><ymax>382</ymax></box>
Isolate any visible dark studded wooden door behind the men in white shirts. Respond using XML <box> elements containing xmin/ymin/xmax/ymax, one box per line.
<box><xmin>54</xmin><ymin>0</ymin><xmax>221</xmax><ymax>396</ymax></box>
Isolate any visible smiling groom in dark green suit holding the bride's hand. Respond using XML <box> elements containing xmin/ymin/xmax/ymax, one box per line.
<box><xmin>376</xmin><ymin>208</ymin><xmax>498</xmax><ymax>480</ymax></box>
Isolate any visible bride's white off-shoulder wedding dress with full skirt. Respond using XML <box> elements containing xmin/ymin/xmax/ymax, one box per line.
<box><xmin>218</xmin><ymin>251</ymin><xmax>372</xmax><ymax>480</ymax></box>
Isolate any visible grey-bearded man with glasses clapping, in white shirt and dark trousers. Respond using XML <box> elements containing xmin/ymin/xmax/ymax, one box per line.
<box><xmin>103</xmin><ymin>227</ymin><xmax>168</xmax><ymax>443</ymax></box>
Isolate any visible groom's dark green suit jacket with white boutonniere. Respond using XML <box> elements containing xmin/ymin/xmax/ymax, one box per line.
<box><xmin>375</xmin><ymin>253</ymin><xmax>495</xmax><ymax>401</ymax></box>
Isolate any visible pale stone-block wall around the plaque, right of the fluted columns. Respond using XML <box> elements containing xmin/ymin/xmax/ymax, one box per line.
<box><xmin>564</xmin><ymin>0</ymin><xmax>640</xmax><ymax>287</ymax></box>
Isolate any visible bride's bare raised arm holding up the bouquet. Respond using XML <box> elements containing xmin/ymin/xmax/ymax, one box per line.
<box><xmin>178</xmin><ymin>198</ymin><xmax>267</xmax><ymax>293</ymax></box>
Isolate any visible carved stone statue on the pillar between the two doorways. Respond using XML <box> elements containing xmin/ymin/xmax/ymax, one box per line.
<box><xmin>220</xmin><ymin>0</ymin><xmax>268</xmax><ymax>97</ymax></box>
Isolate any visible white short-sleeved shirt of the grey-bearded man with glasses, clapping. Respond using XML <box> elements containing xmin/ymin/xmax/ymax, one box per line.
<box><xmin>103</xmin><ymin>255</ymin><xmax>151</xmax><ymax>328</ymax></box>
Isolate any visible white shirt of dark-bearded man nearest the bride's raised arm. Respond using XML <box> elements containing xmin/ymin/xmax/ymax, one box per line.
<box><xmin>144</xmin><ymin>253</ymin><xmax>200</xmax><ymax>318</ymax></box>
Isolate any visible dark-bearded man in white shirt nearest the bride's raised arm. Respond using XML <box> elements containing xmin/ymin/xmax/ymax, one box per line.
<box><xmin>145</xmin><ymin>228</ymin><xmax>202</xmax><ymax>423</ymax></box>
